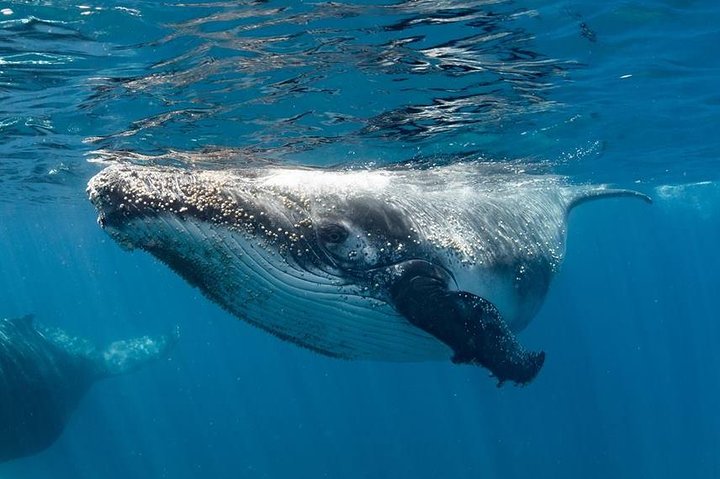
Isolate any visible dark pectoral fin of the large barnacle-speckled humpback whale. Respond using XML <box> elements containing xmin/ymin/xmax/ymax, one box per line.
<box><xmin>391</xmin><ymin>260</ymin><xmax>545</xmax><ymax>386</ymax></box>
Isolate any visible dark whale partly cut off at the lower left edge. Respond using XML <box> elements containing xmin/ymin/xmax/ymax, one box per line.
<box><xmin>0</xmin><ymin>316</ymin><xmax>177</xmax><ymax>462</ymax></box>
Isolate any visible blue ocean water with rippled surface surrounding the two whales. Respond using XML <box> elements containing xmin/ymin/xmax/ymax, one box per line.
<box><xmin>0</xmin><ymin>0</ymin><xmax>720</xmax><ymax>479</ymax></box>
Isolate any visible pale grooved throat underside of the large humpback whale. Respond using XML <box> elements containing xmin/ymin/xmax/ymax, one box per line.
<box><xmin>120</xmin><ymin>214</ymin><xmax>452</xmax><ymax>362</ymax></box>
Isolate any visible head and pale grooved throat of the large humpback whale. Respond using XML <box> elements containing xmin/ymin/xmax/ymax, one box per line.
<box><xmin>88</xmin><ymin>165</ymin><xmax>451</xmax><ymax>361</ymax></box>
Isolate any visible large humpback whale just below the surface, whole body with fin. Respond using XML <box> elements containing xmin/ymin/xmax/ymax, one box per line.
<box><xmin>88</xmin><ymin>162</ymin><xmax>649</xmax><ymax>384</ymax></box>
